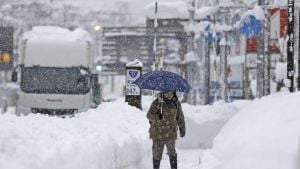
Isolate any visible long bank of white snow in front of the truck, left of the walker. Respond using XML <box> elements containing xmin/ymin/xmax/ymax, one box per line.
<box><xmin>0</xmin><ymin>99</ymin><xmax>151</xmax><ymax>169</ymax></box>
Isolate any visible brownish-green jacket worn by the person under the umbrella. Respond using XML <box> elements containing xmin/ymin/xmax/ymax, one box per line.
<box><xmin>147</xmin><ymin>98</ymin><xmax>185</xmax><ymax>140</ymax></box>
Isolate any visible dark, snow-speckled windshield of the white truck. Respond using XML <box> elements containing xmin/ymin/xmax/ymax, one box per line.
<box><xmin>21</xmin><ymin>67</ymin><xmax>90</xmax><ymax>94</ymax></box>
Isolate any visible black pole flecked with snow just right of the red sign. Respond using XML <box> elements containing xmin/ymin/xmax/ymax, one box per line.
<box><xmin>287</xmin><ymin>0</ymin><xmax>295</xmax><ymax>92</ymax></box>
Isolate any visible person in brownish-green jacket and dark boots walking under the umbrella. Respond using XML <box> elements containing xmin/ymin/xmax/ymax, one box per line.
<box><xmin>147</xmin><ymin>92</ymin><xmax>185</xmax><ymax>169</ymax></box>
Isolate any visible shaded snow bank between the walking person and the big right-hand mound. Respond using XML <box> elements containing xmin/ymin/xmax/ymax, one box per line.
<box><xmin>178</xmin><ymin>101</ymin><xmax>250</xmax><ymax>149</ymax></box>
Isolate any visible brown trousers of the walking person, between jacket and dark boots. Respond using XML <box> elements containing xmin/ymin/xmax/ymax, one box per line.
<box><xmin>152</xmin><ymin>140</ymin><xmax>176</xmax><ymax>160</ymax></box>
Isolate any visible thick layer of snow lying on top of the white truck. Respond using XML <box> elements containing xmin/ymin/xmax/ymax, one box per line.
<box><xmin>23</xmin><ymin>26</ymin><xmax>92</xmax><ymax>42</ymax></box>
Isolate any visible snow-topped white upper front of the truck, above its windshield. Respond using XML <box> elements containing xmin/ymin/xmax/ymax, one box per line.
<box><xmin>22</xmin><ymin>26</ymin><xmax>92</xmax><ymax>67</ymax></box>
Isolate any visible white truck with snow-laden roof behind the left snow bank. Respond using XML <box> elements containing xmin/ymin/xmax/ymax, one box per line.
<box><xmin>12</xmin><ymin>26</ymin><xmax>100</xmax><ymax>114</ymax></box>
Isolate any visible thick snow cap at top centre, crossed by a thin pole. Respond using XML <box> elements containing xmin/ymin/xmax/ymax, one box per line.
<box><xmin>144</xmin><ymin>1</ymin><xmax>189</xmax><ymax>19</ymax></box>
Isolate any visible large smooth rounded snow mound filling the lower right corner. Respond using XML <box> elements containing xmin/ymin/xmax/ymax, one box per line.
<box><xmin>200</xmin><ymin>93</ymin><xmax>300</xmax><ymax>169</ymax></box>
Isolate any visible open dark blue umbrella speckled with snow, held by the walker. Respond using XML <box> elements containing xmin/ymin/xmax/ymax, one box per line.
<box><xmin>133</xmin><ymin>71</ymin><xmax>191</xmax><ymax>92</ymax></box>
